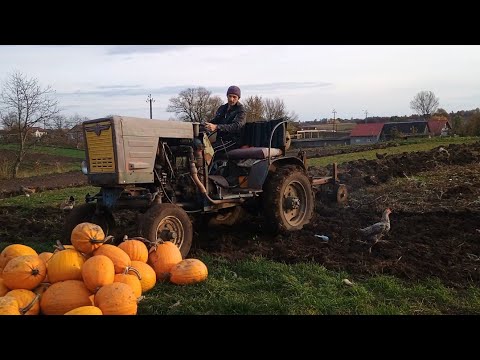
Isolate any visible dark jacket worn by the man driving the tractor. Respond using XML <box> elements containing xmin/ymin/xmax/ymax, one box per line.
<box><xmin>210</xmin><ymin>102</ymin><xmax>246</xmax><ymax>142</ymax></box>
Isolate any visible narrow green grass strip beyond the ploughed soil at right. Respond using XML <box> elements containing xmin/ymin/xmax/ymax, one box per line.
<box><xmin>307</xmin><ymin>137</ymin><xmax>480</xmax><ymax>167</ymax></box>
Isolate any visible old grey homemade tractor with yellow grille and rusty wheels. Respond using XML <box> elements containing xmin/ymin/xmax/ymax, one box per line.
<box><xmin>65</xmin><ymin>116</ymin><xmax>347</xmax><ymax>257</ymax></box>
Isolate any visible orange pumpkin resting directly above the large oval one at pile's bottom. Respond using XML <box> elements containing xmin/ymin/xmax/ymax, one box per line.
<box><xmin>48</xmin><ymin>249</ymin><xmax>85</xmax><ymax>284</ymax></box>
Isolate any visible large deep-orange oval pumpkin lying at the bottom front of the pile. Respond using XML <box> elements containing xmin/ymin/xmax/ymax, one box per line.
<box><xmin>40</xmin><ymin>278</ymin><xmax>92</xmax><ymax>315</ymax></box>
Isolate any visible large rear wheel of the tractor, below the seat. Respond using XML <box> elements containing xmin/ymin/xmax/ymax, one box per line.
<box><xmin>263</xmin><ymin>165</ymin><xmax>314</xmax><ymax>233</ymax></box>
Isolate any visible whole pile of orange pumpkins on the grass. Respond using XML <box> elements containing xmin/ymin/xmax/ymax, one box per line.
<box><xmin>0</xmin><ymin>222</ymin><xmax>208</xmax><ymax>315</ymax></box>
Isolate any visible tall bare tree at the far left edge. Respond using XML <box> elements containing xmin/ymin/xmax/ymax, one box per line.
<box><xmin>0</xmin><ymin>72</ymin><xmax>59</xmax><ymax>178</ymax></box>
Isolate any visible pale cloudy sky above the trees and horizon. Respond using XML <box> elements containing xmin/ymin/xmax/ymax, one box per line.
<box><xmin>0</xmin><ymin>45</ymin><xmax>480</xmax><ymax>121</ymax></box>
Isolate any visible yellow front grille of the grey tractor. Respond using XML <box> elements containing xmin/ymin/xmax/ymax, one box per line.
<box><xmin>85</xmin><ymin>121</ymin><xmax>115</xmax><ymax>173</ymax></box>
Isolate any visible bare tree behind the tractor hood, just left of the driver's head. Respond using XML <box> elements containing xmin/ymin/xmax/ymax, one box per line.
<box><xmin>167</xmin><ymin>87</ymin><xmax>222</xmax><ymax>122</ymax></box>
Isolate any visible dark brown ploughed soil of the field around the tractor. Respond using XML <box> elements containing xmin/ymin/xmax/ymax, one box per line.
<box><xmin>0</xmin><ymin>139</ymin><xmax>480</xmax><ymax>313</ymax></box>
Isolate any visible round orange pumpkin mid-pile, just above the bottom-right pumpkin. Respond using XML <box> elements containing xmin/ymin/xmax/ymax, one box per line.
<box><xmin>82</xmin><ymin>255</ymin><xmax>115</xmax><ymax>292</ymax></box>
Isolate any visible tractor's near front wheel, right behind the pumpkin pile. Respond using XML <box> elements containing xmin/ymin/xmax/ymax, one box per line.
<box><xmin>142</xmin><ymin>203</ymin><xmax>193</xmax><ymax>258</ymax></box>
